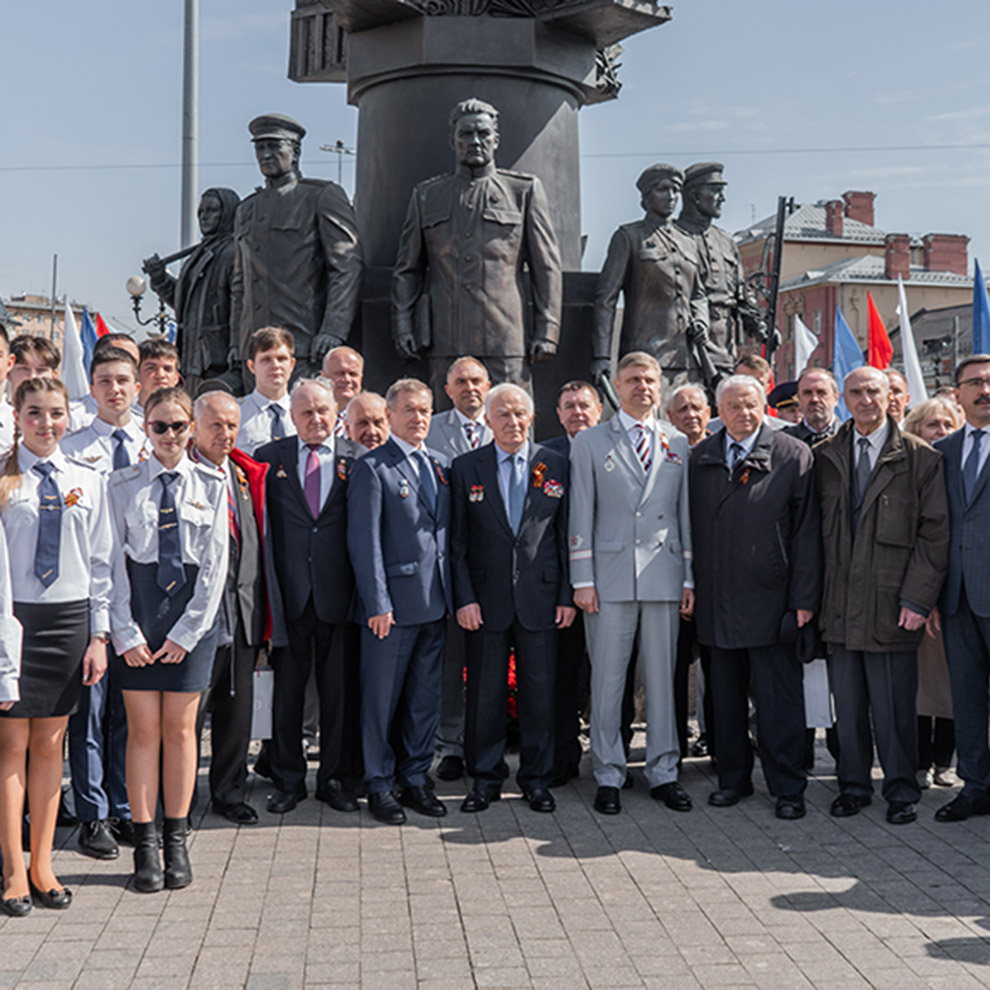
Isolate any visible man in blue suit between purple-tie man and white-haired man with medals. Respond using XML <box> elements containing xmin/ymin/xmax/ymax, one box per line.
<box><xmin>347</xmin><ymin>378</ymin><xmax>451</xmax><ymax>825</ymax></box>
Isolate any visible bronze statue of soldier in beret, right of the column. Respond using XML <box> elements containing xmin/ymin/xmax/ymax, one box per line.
<box><xmin>591</xmin><ymin>164</ymin><xmax>716</xmax><ymax>398</ymax></box>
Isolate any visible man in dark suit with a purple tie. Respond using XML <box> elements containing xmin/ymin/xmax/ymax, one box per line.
<box><xmin>255</xmin><ymin>379</ymin><xmax>361</xmax><ymax>814</ymax></box>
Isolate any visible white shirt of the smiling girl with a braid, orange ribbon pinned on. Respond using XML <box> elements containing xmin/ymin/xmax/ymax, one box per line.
<box><xmin>0</xmin><ymin>444</ymin><xmax>113</xmax><ymax>635</ymax></box>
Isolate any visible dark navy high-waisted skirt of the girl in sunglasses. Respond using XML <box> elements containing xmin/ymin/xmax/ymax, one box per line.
<box><xmin>110</xmin><ymin>559</ymin><xmax>220</xmax><ymax>692</ymax></box>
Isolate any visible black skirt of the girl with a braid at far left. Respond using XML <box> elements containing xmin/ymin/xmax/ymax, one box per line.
<box><xmin>0</xmin><ymin>600</ymin><xmax>89</xmax><ymax>718</ymax></box>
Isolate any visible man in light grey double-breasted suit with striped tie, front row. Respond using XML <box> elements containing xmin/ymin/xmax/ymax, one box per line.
<box><xmin>569</xmin><ymin>351</ymin><xmax>694</xmax><ymax>815</ymax></box>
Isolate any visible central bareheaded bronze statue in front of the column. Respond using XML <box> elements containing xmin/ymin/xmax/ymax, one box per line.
<box><xmin>392</xmin><ymin>99</ymin><xmax>562</xmax><ymax>403</ymax></box>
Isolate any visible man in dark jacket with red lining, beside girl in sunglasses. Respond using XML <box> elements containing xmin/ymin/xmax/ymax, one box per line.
<box><xmin>193</xmin><ymin>391</ymin><xmax>270</xmax><ymax>825</ymax></box>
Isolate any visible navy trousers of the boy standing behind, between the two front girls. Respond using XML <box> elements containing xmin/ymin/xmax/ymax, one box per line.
<box><xmin>68</xmin><ymin>672</ymin><xmax>131</xmax><ymax>822</ymax></box>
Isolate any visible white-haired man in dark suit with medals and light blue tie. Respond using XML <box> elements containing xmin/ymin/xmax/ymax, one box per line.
<box><xmin>450</xmin><ymin>383</ymin><xmax>576</xmax><ymax>812</ymax></box>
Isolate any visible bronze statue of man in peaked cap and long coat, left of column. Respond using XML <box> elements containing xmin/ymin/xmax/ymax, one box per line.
<box><xmin>231</xmin><ymin>113</ymin><xmax>364</xmax><ymax>377</ymax></box>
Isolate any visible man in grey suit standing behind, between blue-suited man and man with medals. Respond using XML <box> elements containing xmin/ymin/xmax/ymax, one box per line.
<box><xmin>426</xmin><ymin>357</ymin><xmax>492</xmax><ymax>780</ymax></box>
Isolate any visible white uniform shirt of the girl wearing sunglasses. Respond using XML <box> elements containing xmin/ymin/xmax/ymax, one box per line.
<box><xmin>108</xmin><ymin>454</ymin><xmax>230</xmax><ymax>654</ymax></box>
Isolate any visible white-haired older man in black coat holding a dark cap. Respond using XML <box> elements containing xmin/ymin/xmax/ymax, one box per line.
<box><xmin>689</xmin><ymin>375</ymin><xmax>821</xmax><ymax>819</ymax></box>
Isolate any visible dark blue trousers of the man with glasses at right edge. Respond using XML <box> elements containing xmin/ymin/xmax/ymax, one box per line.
<box><xmin>942</xmin><ymin>587</ymin><xmax>990</xmax><ymax>800</ymax></box>
